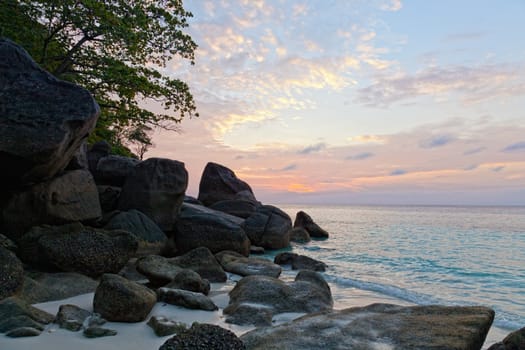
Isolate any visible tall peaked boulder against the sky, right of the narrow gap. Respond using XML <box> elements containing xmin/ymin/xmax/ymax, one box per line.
<box><xmin>199</xmin><ymin>162</ymin><xmax>257</xmax><ymax>206</ymax></box>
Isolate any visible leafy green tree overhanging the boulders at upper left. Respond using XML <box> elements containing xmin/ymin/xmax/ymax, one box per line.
<box><xmin>0</xmin><ymin>0</ymin><xmax>198</xmax><ymax>156</ymax></box>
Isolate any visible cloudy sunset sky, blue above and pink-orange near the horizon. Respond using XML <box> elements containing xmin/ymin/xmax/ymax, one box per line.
<box><xmin>146</xmin><ymin>0</ymin><xmax>525</xmax><ymax>205</ymax></box>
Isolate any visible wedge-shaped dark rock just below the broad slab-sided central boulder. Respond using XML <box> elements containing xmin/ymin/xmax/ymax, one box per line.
<box><xmin>170</xmin><ymin>247</ymin><xmax>226</xmax><ymax>282</ymax></box>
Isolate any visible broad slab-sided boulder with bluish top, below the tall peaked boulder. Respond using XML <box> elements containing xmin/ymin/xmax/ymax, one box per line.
<box><xmin>174</xmin><ymin>203</ymin><xmax>250</xmax><ymax>256</ymax></box>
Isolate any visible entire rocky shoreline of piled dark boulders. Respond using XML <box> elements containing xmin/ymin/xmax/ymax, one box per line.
<box><xmin>0</xmin><ymin>39</ymin><xmax>523</xmax><ymax>350</ymax></box>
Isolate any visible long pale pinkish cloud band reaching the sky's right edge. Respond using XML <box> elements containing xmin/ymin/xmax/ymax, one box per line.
<box><xmin>355</xmin><ymin>63</ymin><xmax>525</xmax><ymax>108</ymax></box>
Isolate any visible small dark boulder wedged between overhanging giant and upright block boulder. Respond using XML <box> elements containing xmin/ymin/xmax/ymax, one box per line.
<box><xmin>94</xmin><ymin>155</ymin><xmax>140</xmax><ymax>187</ymax></box>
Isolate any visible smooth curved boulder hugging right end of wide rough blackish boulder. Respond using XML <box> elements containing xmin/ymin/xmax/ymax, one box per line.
<box><xmin>104</xmin><ymin>209</ymin><xmax>168</xmax><ymax>255</ymax></box>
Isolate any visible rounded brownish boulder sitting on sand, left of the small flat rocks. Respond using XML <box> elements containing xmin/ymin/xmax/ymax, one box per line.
<box><xmin>93</xmin><ymin>274</ymin><xmax>157</xmax><ymax>322</ymax></box>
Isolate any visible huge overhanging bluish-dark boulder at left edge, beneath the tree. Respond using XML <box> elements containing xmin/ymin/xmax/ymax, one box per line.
<box><xmin>0</xmin><ymin>38</ymin><xmax>100</xmax><ymax>190</ymax></box>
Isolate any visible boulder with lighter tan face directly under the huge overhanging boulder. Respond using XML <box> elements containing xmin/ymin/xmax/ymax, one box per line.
<box><xmin>2</xmin><ymin>170</ymin><xmax>102</xmax><ymax>240</ymax></box>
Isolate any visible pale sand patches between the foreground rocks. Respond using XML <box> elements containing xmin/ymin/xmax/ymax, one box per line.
<box><xmin>0</xmin><ymin>276</ymin><xmax>508</xmax><ymax>350</ymax></box>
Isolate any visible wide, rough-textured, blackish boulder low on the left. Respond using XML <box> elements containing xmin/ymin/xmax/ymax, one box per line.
<box><xmin>20</xmin><ymin>223</ymin><xmax>138</xmax><ymax>277</ymax></box>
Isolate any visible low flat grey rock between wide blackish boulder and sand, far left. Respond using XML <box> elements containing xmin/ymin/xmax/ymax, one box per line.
<box><xmin>19</xmin><ymin>272</ymin><xmax>98</xmax><ymax>304</ymax></box>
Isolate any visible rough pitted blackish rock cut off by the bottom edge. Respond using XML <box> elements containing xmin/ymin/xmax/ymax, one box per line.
<box><xmin>159</xmin><ymin>323</ymin><xmax>246</xmax><ymax>350</ymax></box>
